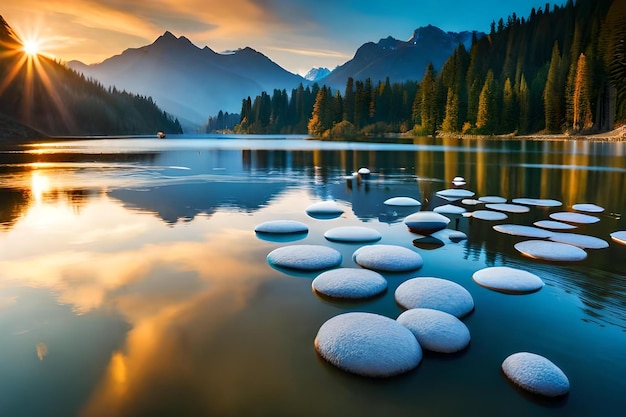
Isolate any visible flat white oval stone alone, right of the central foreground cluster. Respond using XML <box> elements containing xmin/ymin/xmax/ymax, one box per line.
<box><xmin>472</xmin><ymin>266</ymin><xmax>545</xmax><ymax>294</ymax></box>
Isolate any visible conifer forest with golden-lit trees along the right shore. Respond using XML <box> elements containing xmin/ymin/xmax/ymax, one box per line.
<box><xmin>231</xmin><ymin>0</ymin><xmax>626</xmax><ymax>139</ymax></box>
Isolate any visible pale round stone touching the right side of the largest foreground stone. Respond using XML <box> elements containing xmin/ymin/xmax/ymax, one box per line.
<box><xmin>397</xmin><ymin>308</ymin><xmax>470</xmax><ymax>353</ymax></box>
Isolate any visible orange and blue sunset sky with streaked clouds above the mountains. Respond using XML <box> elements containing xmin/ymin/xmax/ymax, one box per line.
<box><xmin>0</xmin><ymin>0</ymin><xmax>552</xmax><ymax>74</ymax></box>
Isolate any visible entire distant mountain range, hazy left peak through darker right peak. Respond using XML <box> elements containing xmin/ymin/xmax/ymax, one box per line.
<box><xmin>68</xmin><ymin>26</ymin><xmax>484</xmax><ymax>132</ymax></box>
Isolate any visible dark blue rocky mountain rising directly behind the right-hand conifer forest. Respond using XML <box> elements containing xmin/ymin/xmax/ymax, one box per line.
<box><xmin>324</xmin><ymin>25</ymin><xmax>484</xmax><ymax>89</ymax></box>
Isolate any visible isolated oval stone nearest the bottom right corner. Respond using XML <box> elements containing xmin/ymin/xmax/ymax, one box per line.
<box><xmin>502</xmin><ymin>352</ymin><xmax>569</xmax><ymax>397</ymax></box>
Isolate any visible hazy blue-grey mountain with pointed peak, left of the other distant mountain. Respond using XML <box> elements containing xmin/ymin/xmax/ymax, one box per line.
<box><xmin>68</xmin><ymin>32</ymin><xmax>306</xmax><ymax>130</ymax></box>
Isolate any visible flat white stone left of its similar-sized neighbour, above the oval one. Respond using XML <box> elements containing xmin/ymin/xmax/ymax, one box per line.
<box><xmin>267</xmin><ymin>245</ymin><xmax>342</xmax><ymax>271</ymax></box>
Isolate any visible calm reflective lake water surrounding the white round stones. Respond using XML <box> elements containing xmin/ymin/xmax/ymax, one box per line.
<box><xmin>0</xmin><ymin>136</ymin><xmax>626</xmax><ymax>417</ymax></box>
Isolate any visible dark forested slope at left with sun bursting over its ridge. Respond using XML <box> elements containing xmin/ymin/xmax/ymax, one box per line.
<box><xmin>0</xmin><ymin>16</ymin><xmax>181</xmax><ymax>136</ymax></box>
